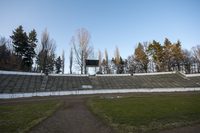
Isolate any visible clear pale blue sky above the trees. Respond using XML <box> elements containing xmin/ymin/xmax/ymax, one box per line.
<box><xmin>0</xmin><ymin>0</ymin><xmax>200</xmax><ymax>73</ymax></box>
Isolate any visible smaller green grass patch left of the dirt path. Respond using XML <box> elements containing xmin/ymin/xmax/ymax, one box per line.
<box><xmin>0</xmin><ymin>101</ymin><xmax>61</xmax><ymax>133</ymax></box>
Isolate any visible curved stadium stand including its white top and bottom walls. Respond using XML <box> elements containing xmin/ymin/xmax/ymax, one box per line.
<box><xmin>0</xmin><ymin>71</ymin><xmax>200</xmax><ymax>98</ymax></box>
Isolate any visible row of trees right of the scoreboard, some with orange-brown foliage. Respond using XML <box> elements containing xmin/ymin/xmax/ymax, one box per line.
<box><xmin>99</xmin><ymin>38</ymin><xmax>200</xmax><ymax>74</ymax></box>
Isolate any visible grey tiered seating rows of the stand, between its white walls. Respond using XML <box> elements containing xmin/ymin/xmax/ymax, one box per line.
<box><xmin>0</xmin><ymin>73</ymin><xmax>200</xmax><ymax>93</ymax></box>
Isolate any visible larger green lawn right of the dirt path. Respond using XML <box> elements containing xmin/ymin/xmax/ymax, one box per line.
<box><xmin>88</xmin><ymin>93</ymin><xmax>200</xmax><ymax>133</ymax></box>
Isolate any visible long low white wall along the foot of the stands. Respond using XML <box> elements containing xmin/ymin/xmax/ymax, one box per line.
<box><xmin>0</xmin><ymin>88</ymin><xmax>200</xmax><ymax>99</ymax></box>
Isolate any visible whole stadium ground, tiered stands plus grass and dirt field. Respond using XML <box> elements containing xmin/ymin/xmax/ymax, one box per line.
<box><xmin>0</xmin><ymin>71</ymin><xmax>200</xmax><ymax>133</ymax></box>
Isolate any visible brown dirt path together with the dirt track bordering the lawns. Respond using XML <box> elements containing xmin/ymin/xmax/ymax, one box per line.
<box><xmin>0</xmin><ymin>93</ymin><xmax>200</xmax><ymax>133</ymax></box>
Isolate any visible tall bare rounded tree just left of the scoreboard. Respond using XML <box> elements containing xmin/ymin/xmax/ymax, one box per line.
<box><xmin>72</xmin><ymin>28</ymin><xmax>93</xmax><ymax>74</ymax></box>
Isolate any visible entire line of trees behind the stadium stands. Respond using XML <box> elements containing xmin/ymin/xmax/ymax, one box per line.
<box><xmin>0</xmin><ymin>26</ymin><xmax>200</xmax><ymax>74</ymax></box>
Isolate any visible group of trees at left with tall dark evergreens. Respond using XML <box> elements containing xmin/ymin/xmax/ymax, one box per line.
<box><xmin>0</xmin><ymin>25</ymin><xmax>64</xmax><ymax>73</ymax></box>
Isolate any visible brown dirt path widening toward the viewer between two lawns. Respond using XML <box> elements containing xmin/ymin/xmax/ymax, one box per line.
<box><xmin>30</xmin><ymin>98</ymin><xmax>113</xmax><ymax>133</ymax></box>
